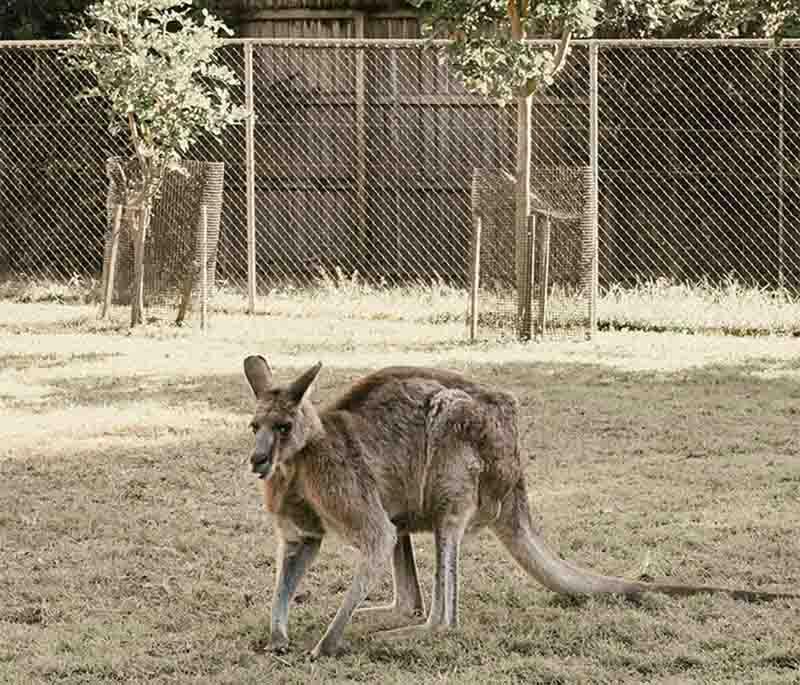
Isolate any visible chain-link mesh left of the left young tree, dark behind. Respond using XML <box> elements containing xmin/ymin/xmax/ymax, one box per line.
<box><xmin>0</xmin><ymin>44</ymin><xmax>123</xmax><ymax>279</ymax></box>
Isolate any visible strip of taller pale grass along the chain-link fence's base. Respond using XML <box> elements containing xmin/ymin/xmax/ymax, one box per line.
<box><xmin>0</xmin><ymin>271</ymin><xmax>800</xmax><ymax>336</ymax></box>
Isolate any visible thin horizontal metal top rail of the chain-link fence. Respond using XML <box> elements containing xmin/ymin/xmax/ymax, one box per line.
<box><xmin>0</xmin><ymin>38</ymin><xmax>800</xmax><ymax>50</ymax></box>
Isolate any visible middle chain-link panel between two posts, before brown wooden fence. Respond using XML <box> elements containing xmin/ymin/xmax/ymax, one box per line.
<box><xmin>247</xmin><ymin>40</ymin><xmax>588</xmax><ymax>328</ymax></box>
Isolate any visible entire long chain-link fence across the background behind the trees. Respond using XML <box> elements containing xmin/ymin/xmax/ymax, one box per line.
<box><xmin>0</xmin><ymin>40</ymin><xmax>800</xmax><ymax>334</ymax></box>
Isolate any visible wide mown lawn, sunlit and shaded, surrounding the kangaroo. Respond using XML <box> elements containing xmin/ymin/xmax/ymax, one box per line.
<box><xmin>0</xmin><ymin>298</ymin><xmax>800</xmax><ymax>685</ymax></box>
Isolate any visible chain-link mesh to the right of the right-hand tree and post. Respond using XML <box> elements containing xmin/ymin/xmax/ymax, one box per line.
<box><xmin>599</xmin><ymin>44</ymin><xmax>800</xmax><ymax>293</ymax></box>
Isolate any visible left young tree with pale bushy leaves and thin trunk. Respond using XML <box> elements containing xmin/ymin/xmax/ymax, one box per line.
<box><xmin>67</xmin><ymin>0</ymin><xmax>246</xmax><ymax>326</ymax></box>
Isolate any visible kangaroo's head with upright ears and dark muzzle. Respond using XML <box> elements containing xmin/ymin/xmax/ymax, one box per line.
<box><xmin>244</xmin><ymin>355</ymin><xmax>322</xmax><ymax>478</ymax></box>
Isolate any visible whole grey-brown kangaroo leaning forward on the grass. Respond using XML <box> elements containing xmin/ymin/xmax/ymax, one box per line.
<box><xmin>244</xmin><ymin>355</ymin><xmax>798</xmax><ymax>658</ymax></box>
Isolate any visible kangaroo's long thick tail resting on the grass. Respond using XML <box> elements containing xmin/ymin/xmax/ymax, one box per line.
<box><xmin>494</xmin><ymin>479</ymin><xmax>800</xmax><ymax>601</ymax></box>
